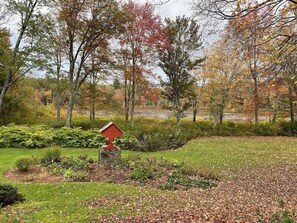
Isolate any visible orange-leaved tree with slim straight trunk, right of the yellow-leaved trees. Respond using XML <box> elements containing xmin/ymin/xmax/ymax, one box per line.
<box><xmin>228</xmin><ymin>11</ymin><xmax>275</xmax><ymax>127</ymax></box>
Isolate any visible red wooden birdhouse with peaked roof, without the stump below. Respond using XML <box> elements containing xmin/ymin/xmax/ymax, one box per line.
<box><xmin>99</xmin><ymin>122</ymin><xmax>123</xmax><ymax>149</ymax></box>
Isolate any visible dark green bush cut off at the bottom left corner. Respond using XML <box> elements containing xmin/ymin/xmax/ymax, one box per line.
<box><xmin>0</xmin><ymin>184</ymin><xmax>25</xmax><ymax>208</ymax></box>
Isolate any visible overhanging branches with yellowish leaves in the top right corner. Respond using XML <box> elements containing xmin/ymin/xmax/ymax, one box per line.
<box><xmin>193</xmin><ymin>0</ymin><xmax>297</xmax><ymax>60</ymax></box>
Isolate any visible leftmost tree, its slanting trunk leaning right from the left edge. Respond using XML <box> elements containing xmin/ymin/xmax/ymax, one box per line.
<box><xmin>0</xmin><ymin>0</ymin><xmax>50</xmax><ymax>115</ymax></box>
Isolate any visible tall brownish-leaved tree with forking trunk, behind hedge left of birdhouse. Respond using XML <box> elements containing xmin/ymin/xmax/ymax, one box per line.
<box><xmin>58</xmin><ymin>0</ymin><xmax>123</xmax><ymax>126</ymax></box>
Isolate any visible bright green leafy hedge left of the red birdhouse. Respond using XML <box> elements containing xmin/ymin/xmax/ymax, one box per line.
<box><xmin>0</xmin><ymin>125</ymin><xmax>106</xmax><ymax>148</ymax></box>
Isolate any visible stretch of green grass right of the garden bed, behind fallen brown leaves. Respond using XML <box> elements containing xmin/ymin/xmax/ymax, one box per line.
<box><xmin>137</xmin><ymin>137</ymin><xmax>297</xmax><ymax>173</ymax></box>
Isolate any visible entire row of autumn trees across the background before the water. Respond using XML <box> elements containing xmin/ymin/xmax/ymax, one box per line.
<box><xmin>0</xmin><ymin>0</ymin><xmax>297</xmax><ymax>130</ymax></box>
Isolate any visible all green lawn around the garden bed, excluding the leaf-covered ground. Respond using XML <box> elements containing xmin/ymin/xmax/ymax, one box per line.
<box><xmin>0</xmin><ymin>137</ymin><xmax>297</xmax><ymax>222</ymax></box>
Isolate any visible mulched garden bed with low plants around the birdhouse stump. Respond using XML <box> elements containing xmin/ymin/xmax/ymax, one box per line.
<box><xmin>5</xmin><ymin>150</ymin><xmax>218</xmax><ymax>190</ymax></box>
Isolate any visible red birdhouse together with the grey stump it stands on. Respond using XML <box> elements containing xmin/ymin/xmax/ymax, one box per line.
<box><xmin>99</xmin><ymin>122</ymin><xmax>123</xmax><ymax>164</ymax></box>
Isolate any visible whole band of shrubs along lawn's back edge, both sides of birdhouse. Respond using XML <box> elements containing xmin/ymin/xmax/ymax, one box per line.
<box><xmin>0</xmin><ymin>118</ymin><xmax>297</xmax><ymax>152</ymax></box>
